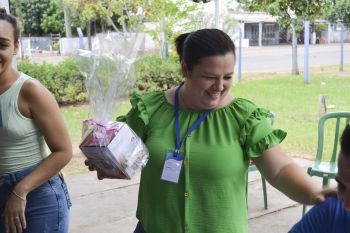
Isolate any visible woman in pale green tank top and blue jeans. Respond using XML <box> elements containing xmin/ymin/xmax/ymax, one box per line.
<box><xmin>0</xmin><ymin>9</ymin><xmax>72</xmax><ymax>233</ymax></box>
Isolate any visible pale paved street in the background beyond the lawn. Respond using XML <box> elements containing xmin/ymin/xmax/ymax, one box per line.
<box><xmin>30</xmin><ymin>43</ymin><xmax>350</xmax><ymax>73</ymax></box>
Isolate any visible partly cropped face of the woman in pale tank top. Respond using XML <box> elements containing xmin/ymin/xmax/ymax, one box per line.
<box><xmin>0</xmin><ymin>20</ymin><xmax>18</xmax><ymax>77</ymax></box>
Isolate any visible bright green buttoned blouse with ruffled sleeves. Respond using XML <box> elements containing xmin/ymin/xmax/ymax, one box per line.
<box><xmin>118</xmin><ymin>92</ymin><xmax>286</xmax><ymax>233</ymax></box>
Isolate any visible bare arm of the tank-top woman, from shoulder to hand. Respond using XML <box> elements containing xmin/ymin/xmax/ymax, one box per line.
<box><xmin>3</xmin><ymin>80</ymin><xmax>72</xmax><ymax>232</ymax></box>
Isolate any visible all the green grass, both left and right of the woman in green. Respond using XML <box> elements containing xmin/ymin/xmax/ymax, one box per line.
<box><xmin>61</xmin><ymin>72</ymin><xmax>350</xmax><ymax>175</ymax></box>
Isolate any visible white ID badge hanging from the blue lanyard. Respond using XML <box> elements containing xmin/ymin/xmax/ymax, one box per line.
<box><xmin>160</xmin><ymin>152</ymin><xmax>184</xmax><ymax>184</ymax></box>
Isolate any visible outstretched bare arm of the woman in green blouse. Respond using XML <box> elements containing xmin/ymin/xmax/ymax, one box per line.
<box><xmin>252</xmin><ymin>145</ymin><xmax>335</xmax><ymax>205</ymax></box>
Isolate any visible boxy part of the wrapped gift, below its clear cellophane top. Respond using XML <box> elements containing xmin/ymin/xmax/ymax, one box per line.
<box><xmin>79</xmin><ymin>120</ymin><xmax>149</xmax><ymax>179</ymax></box>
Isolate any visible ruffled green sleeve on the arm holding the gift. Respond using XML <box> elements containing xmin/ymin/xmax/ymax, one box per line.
<box><xmin>116</xmin><ymin>92</ymin><xmax>163</xmax><ymax>140</ymax></box>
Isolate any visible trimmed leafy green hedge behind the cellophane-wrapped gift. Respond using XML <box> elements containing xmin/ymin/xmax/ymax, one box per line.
<box><xmin>18</xmin><ymin>55</ymin><xmax>182</xmax><ymax>105</ymax></box>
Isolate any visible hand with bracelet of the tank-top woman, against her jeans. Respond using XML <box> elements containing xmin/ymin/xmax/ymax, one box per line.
<box><xmin>2</xmin><ymin>190</ymin><xmax>27</xmax><ymax>233</ymax></box>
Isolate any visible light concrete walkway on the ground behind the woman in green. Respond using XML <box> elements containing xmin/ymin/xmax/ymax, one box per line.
<box><xmin>67</xmin><ymin>159</ymin><xmax>334</xmax><ymax>233</ymax></box>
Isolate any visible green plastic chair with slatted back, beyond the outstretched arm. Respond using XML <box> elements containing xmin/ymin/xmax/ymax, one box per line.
<box><xmin>303</xmin><ymin>112</ymin><xmax>350</xmax><ymax>215</ymax></box>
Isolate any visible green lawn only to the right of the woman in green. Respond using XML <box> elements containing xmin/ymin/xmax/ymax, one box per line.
<box><xmin>232</xmin><ymin>73</ymin><xmax>350</xmax><ymax>158</ymax></box>
